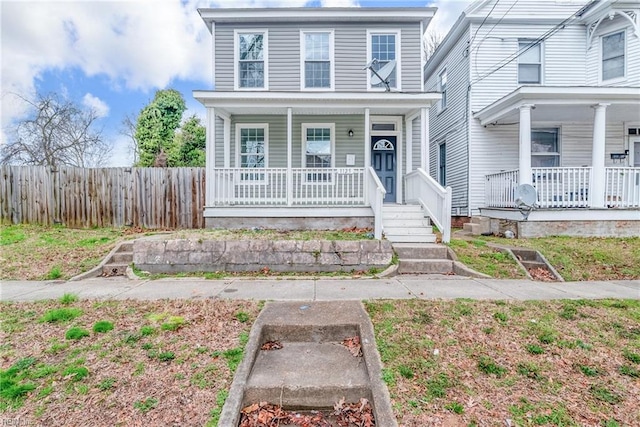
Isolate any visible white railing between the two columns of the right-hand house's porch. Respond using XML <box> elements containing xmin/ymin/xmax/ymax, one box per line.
<box><xmin>531</xmin><ymin>167</ymin><xmax>591</xmax><ymax>208</ymax></box>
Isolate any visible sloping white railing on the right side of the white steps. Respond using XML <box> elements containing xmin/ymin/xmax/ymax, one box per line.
<box><xmin>405</xmin><ymin>168</ymin><xmax>451</xmax><ymax>243</ymax></box>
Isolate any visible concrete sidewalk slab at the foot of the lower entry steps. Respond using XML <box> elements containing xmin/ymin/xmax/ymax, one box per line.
<box><xmin>399</xmin><ymin>278</ymin><xmax>509</xmax><ymax>300</ymax></box>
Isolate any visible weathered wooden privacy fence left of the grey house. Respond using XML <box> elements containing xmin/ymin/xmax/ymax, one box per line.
<box><xmin>0</xmin><ymin>165</ymin><xmax>205</xmax><ymax>229</ymax></box>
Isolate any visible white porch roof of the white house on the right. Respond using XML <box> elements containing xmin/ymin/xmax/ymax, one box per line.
<box><xmin>473</xmin><ymin>86</ymin><xmax>640</xmax><ymax>126</ymax></box>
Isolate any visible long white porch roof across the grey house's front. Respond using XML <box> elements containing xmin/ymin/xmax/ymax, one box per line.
<box><xmin>193</xmin><ymin>90</ymin><xmax>442</xmax><ymax>115</ymax></box>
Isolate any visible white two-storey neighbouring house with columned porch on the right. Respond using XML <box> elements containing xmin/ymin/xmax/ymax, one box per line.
<box><xmin>424</xmin><ymin>0</ymin><xmax>640</xmax><ymax>235</ymax></box>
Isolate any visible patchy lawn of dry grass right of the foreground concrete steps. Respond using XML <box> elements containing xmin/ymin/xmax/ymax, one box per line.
<box><xmin>367</xmin><ymin>300</ymin><xmax>640</xmax><ymax>427</ymax></box>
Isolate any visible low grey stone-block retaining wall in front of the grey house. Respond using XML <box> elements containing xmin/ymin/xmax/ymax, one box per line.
<box><xmin>133</xmin><ymin>239</ymin><xmax>393</xmax><ymax>273</ymax></box>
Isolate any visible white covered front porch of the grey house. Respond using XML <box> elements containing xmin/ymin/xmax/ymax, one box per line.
<box><xmin>194</xmin><ymin>91</ymin><xmax>450</xmax><ymax>238</ymax></box>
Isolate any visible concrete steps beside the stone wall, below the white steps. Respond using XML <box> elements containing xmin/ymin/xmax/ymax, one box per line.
<box><xmin>393</xmin><ymin>243</ymin><xmax>454</xmax><ymax>274</ymax></box>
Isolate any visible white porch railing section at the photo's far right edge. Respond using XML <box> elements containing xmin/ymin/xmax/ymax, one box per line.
<box><xmin>604</xmin><ymin>168</ymin><xmax>640</xmax><ymax>208</ymax></box>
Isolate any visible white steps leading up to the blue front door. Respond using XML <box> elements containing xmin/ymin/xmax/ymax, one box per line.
<box><xmin>382</xmin><ymin>205</ymin><xmax>436</xmax><ymax>243</ymax></box>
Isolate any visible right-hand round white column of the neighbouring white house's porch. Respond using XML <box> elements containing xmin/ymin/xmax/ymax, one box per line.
<box><xmin>589</xmin><ymin>104</ymin><xmax>609</xmax><ymax>208</ymax></box>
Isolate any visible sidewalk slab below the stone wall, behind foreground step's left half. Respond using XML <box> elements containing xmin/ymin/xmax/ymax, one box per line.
<box><xmin>217</xmin><ymin>280</ymin><xmax>315</xmax><ymax>301</ymax></box>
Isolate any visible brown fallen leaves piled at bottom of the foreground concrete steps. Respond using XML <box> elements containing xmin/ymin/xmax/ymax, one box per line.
<box><xmin>239</xmin><ymin>398</ymin><xmax>376</xmax><ymax>427</ymax></box>
